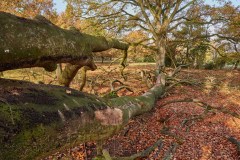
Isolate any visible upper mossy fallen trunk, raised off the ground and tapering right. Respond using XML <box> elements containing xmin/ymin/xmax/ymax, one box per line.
<box><xmin>0</xmin><ymin>12</ymin><xmax>128</xmax><ymax>72</ymax></box>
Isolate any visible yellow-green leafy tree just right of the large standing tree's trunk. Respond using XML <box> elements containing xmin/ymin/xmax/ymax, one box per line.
<box><xmin>168</xmin><ymin>3</ymin><xmax>210</xmax><ymax>68</ymax></box>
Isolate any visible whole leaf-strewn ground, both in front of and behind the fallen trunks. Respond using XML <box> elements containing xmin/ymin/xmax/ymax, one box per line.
<box><xmin>4</xmin><ymin>64</ymin><xmax>240</xmax><ymax>160</ymax></box>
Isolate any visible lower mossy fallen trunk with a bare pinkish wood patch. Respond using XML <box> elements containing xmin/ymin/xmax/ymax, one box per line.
<box><xmin>0</xmin><ymin>75</ymin><xmax>164</xmax><ymax>160</ymax></box>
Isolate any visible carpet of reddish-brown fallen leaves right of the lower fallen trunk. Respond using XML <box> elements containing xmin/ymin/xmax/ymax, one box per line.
<box><xmin>105</xmin><ymin>70</ymin><xmax>240</xmax><ymax>160</ymax></box>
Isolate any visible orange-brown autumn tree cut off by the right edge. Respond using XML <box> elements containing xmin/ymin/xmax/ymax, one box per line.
<box><xmin>212</xmin><ymin>3</ymin><xmax>240</xmax><ymax>69</ymax></box>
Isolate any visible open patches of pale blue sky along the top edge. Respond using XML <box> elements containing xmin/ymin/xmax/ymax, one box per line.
<box><xmin>53</xmin><ymin>0</ymin><xmax>240</xmax><ymax>13</ymax></box>
